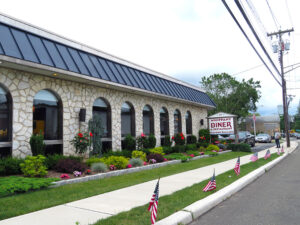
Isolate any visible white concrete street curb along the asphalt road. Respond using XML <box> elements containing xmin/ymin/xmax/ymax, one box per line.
<box><xmin>156</xmin><ymin>144</ymin><xmax>298</xmax><ymax>225</ymax></box>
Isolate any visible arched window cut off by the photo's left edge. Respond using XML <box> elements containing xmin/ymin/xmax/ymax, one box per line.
<box><xmin>0</xmin><ymin>86</ymin><xmax>12</xmax><ymax>157</ymax></box>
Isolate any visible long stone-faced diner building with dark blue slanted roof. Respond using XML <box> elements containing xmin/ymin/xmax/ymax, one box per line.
<box><xmin>0</xmin><ymin>14</ymin><xmax>215</xmax><ymax>157</ymax></box>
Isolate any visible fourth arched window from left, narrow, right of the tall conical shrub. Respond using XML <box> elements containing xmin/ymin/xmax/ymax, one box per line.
<box><xmin>121</xmin><ymin>102</ymin><xmax>135</xmax><ymax>137</ymax></box>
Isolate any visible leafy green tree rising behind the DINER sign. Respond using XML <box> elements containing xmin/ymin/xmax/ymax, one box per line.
<box><xmin>200</xmin><ymin>73</ymin><xmax>261</xmax><ymax>117</ymax></box>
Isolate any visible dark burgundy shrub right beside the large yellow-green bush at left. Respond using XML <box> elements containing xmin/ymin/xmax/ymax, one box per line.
<box><xmin>54</xmin><ymin>158</ymin><xmax>87</xmax><ymax>173</ymax></box>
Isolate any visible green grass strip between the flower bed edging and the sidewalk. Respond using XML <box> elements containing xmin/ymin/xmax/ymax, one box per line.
<box><xmin>0</xmin><ymin>152</ymin><xmax>249</xmax><ymax>220</ymax></box>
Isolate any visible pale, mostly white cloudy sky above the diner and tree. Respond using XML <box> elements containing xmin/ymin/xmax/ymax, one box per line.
<box><xmin>0</xmin><ymin>0</ymin><xmax>300</xmax><ymax>115</ymax></box>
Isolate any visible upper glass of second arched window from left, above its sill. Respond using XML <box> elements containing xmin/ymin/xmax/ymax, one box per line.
<box><xmin>33</xmin><ymin>90</ymin><xmax>60</xmax><ymax>140</ymax></box>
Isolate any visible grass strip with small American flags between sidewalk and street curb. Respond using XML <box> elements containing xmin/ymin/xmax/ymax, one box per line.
<box><xmin>95</xmin><ymin>153</ymin><xmax>279</xmax><ymax>225</ymax></box>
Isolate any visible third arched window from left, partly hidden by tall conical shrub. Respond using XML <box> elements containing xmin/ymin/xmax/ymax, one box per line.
<box><xmin>93</xmin><ymin>98</ymin><xmax>111</xmax><ymax>138</ymax></box>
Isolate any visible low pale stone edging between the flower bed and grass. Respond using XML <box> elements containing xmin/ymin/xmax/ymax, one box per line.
<box><xmin>50</xmin><ymin>150</ymin><xmax>231</xmax><ymax>188</ymax></box>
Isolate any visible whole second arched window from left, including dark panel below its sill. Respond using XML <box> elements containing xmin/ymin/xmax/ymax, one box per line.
<box><xmin>33</xmin><ymin>90</ymin><xmax>62</xmax><ymax>154</ymax></box>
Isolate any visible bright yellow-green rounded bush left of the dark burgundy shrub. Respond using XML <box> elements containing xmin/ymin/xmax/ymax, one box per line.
<box><xmin>20</xmin><ymin>155</ymin><xmax>48</xmax><ymax>177</ymax></box>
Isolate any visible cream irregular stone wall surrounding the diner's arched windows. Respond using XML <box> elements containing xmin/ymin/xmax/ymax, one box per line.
<box><xmin>0</xmin><ymin>68</ymin><xmax>207</xmax><ymax>157</ymax></box>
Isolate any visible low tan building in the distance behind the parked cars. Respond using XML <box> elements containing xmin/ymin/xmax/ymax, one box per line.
<box><xmin>246</xmin><ymin>115</ymin><xmax>280</xmax><ymax>136</ymax></box>
